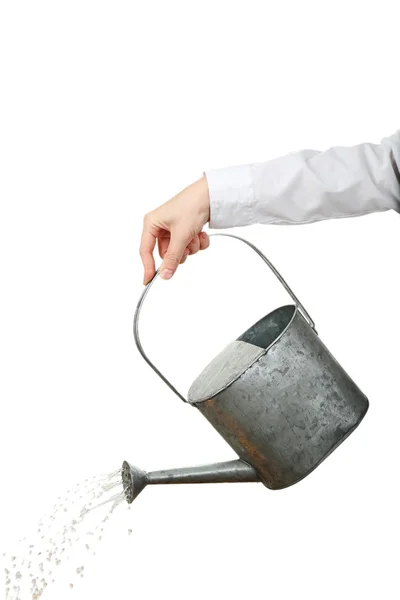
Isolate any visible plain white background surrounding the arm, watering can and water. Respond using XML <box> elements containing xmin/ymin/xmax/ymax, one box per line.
<box><xmin>0</xmin><ymin>0</ymin><xmax>400</xmax><ymax>600</ymax></box>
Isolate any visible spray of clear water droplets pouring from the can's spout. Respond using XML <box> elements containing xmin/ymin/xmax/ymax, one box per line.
<box><xmin>0</xmin><ymin>470</ymin><xmax>131</xmax><ymax>600</ymax></box>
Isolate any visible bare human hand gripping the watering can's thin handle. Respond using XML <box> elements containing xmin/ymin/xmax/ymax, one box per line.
<box><xmin>140</xmin><ymin>176</ymin><xmax>210</xmax><ymax>285</ymax></box>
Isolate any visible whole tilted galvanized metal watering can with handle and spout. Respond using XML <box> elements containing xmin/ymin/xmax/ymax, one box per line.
<box><xmin>122</xmin><ymin>234</ymin><xmax>369</xmax><ymax>503</ymax></box>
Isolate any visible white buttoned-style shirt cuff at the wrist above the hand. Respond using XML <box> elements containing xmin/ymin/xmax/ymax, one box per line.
<box><xmin>204</xmin><ymin>165</ymin><xmax>254</xmax><ymax>229</ymax></box>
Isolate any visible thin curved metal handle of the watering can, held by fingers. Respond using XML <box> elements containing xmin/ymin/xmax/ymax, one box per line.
<box><xmin>133</xmin><ymin>233</ymin><xmax>316</xmax><ymax>402</ymax></box>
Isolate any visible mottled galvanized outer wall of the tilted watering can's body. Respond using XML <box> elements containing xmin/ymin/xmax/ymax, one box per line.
<box><xmin>196</xmin><ymin>307</ymin><xmax>368</xmax><ymax>489</ymax></box>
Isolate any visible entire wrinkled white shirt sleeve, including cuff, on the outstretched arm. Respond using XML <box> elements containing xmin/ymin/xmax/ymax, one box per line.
<box><xmin>205</xmin><ymin>130</ymin><xmax>400</xmax><ymax>229</ymax></box>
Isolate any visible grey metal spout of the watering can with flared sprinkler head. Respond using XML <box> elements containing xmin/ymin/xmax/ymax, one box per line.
<box><xmin>122</xmin><ymin>459</ymin><xmax>260</xmax><ymax>504</ymax></box>
